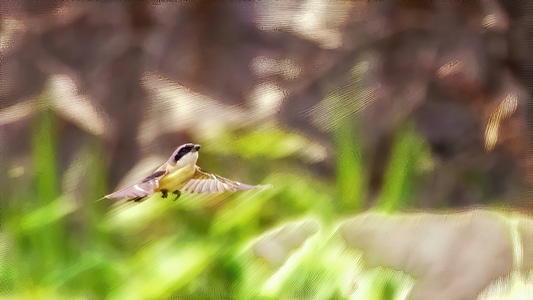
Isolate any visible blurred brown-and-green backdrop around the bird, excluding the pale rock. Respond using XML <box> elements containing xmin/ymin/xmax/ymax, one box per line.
<box><xmin>0</xmin><ymin>0</ymin><xmax>533</xmax><ymax>299</ymax></box>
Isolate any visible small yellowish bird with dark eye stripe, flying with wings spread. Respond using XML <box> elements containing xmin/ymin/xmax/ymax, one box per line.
<box><xmin>104</xmin><ymin>143</ymin><xmax>266</xmax><ymax>202</ymax></box>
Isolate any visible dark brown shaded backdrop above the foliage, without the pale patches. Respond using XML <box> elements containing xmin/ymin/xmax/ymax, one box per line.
<box><xmin>0</xmin><ymin>1</ymin><xmax>533</xmax><ymax>207</ymax></box>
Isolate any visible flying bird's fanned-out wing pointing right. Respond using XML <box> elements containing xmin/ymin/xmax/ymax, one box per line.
<box><xmin>181</xmin><ymin>167</ymin><xmax>265</xmax><ymax>194</ymax></box>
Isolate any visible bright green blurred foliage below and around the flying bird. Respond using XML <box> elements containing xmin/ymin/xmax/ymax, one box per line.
<box><xmin>0</xmin><ymin>83</ymin><xmax>428</xmax><ymax>299</ymax></box>
